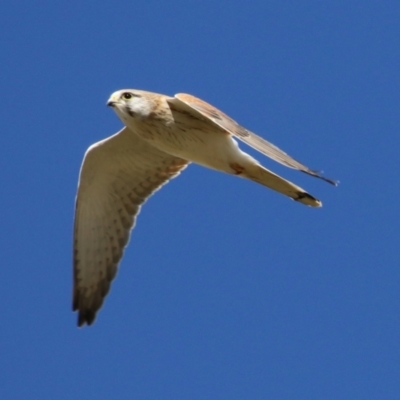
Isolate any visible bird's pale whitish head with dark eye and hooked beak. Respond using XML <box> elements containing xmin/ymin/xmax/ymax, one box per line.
<box><xmin>107</xmin><ymin>89</ymin><xmax>153</xmax><ymax>122</ymax></box>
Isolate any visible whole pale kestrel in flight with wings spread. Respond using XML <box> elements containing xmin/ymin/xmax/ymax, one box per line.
<box><xmin>72</xmin><ymin>89</ymin><xmax>337</xmax><ymax>326</ymax></box>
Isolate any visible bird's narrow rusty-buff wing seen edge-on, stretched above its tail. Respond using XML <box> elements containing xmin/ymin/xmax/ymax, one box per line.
<box><xmin>168</xmin><ymin>93</ymin><xmax>337</xmax><ymax>186</ymax></box>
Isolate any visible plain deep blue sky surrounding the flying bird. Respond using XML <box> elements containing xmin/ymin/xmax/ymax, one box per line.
<box><xmin>0</xmin><ymin>0</ymin><xmax>400</xmax><ymax>399</ymax></box>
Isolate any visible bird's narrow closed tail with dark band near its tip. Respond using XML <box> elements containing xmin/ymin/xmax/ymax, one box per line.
<box><xmin>240</xmin><ymin>163</ymin><xmax>322</xmax><ymax>207</ymax></box>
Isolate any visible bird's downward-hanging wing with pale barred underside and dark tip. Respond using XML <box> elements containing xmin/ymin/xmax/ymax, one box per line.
<box><xmin>73</xmin><ymin>128</ymin><xmax>188</xmax><ymax>326</ymax></box>
